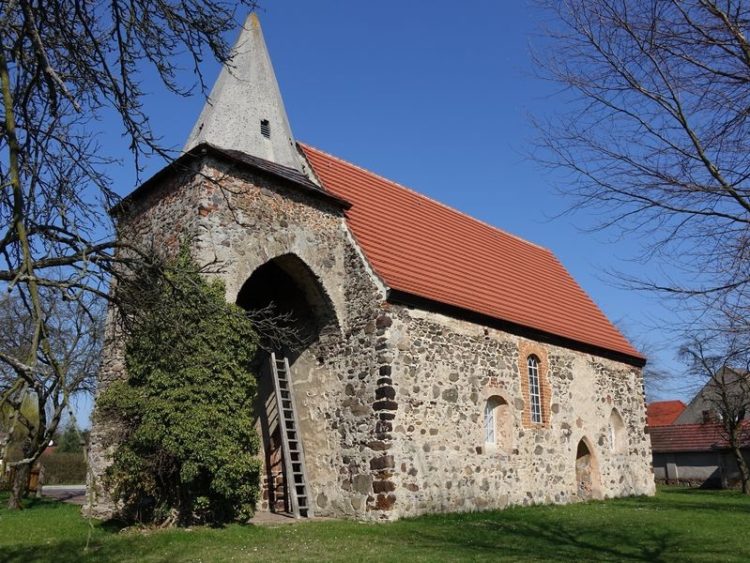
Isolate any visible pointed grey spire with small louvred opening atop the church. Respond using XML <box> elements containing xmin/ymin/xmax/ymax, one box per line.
<box><xmin>184</xmin><ymin>13</ymin><xmax>306</xmax><ymax>172</ymax></box>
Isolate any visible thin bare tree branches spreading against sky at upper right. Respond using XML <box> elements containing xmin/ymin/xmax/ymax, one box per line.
<box><xmin>537</xmin><ymin>0</ymin><xmax>750</xmax><ymax>319</ymax></box>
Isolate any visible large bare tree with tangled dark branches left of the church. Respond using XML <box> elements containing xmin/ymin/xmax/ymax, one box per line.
<box><xmin>0</xmin><ymin>0</ymin><xmax>255</xmax><ymax>505</ymax></box>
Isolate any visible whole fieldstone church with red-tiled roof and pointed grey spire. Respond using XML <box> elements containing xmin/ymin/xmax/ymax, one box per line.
<box><xmin>89</xmin><ymin>15</ymin><xmax>654</xmax><ymax>520</ymax></box>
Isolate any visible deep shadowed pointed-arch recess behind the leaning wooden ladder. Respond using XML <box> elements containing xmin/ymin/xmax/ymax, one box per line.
<box><xmin>237</xmin><ymin>254</ymin><xmax>338</xmax><ymax>512</ymax></box>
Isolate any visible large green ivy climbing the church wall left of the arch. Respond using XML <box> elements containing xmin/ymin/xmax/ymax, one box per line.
<box><xmin>97</xmin><ymin>249</ymin><xmax>261</xmax><ymax>525</ymax></box>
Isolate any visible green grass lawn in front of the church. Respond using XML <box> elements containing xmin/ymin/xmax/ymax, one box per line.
<box><xmin>0</xmin><ymin>488</ymin><xmax>750</xmax><ymax>562</ymax></box>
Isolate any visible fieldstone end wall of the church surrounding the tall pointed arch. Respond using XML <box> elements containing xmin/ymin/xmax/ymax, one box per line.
<box><xmin>188</xmin><ymin>155</ymin><xmax>396</xmax><ymax>519</ymax></box>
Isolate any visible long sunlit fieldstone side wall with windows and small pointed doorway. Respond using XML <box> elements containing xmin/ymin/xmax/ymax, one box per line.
<box><xmin>375</xmin><ymin>306</ymin><xmax>654</xmax><ymax>517</ymax></box>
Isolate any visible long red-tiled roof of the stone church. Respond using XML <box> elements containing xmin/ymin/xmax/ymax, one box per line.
<box><xmin>301</xmin><ymin>144</ymin><xmax>644</xmax><ymax>361</ymax></box>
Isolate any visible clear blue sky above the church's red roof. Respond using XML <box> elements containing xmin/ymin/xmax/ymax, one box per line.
<box><xmin>73</xmin><ymin>0</ymin><xmax>685</xmax><ymax>428</ymax></box>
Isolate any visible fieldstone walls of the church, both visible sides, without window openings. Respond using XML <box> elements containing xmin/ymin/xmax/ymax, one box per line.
<box><xmin>89</xmin><ymin>152</ymin><xmax>653</xmax><ymax>520</ymax></box>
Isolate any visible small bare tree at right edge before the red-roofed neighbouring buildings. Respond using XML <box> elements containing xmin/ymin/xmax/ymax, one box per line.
<box><xmin>682</xmin><ymin>333</ymin><xmax>750</xmax><ymax>494</ymax></box>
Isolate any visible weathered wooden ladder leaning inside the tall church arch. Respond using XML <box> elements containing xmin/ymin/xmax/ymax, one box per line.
<box><xmin>271</xmin><ymin>352</ymin><xmax>313</xmax><ymax>518</ymax></box>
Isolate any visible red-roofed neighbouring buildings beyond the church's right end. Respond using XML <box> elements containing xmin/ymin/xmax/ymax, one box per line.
<box><xmin>647</xmin><ymin>368</ymin><xmax>750</xmax><ymax>488</ymax></box>
